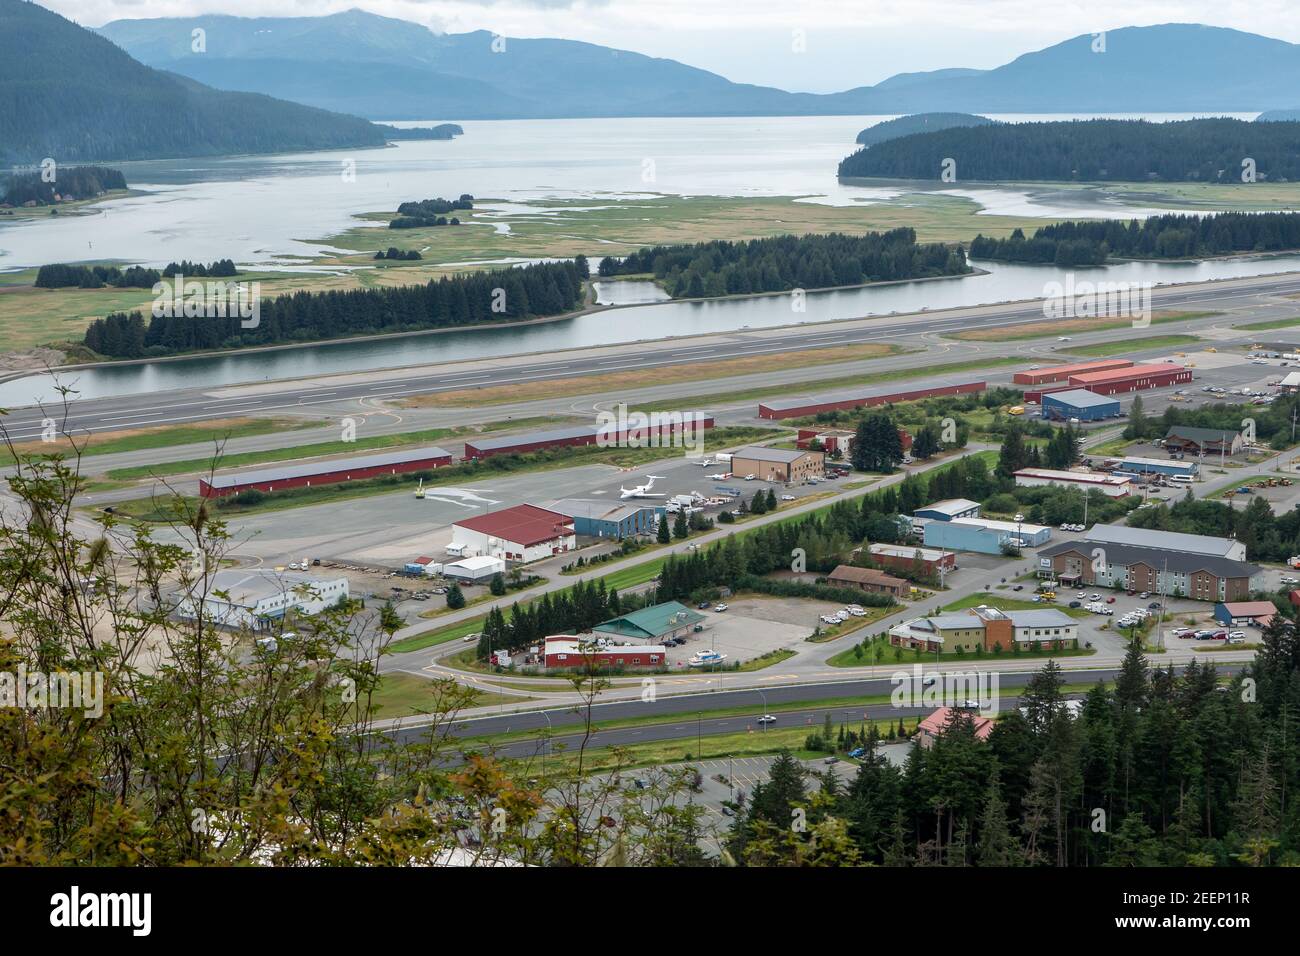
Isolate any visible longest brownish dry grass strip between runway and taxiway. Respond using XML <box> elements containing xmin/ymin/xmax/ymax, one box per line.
<box><xmin>400</xmin><ymin>343</ymin><xmax>905</xmax><ymax>408</ymax></box>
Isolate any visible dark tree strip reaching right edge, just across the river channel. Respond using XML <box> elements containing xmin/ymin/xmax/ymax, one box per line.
<box><xmin>970</xmin><ymin>212</ymin><xmax>1300</xmax><ymax>267</ymax></box>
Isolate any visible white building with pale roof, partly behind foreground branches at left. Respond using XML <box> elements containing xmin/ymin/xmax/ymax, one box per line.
<box><xmin>176</xmin><ymin>568</ymin><xmax>348</xmax><ymax>631</ymax></box>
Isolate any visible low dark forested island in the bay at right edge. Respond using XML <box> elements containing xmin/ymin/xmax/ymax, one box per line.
<box><xmin>840</xmin><ymin>120</ymin><xmax>1300</xmax><ymax>182</ymax></box>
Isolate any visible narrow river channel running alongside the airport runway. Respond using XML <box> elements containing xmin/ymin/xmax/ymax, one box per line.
<box><xmin>0</xmin><ymin>256</ymin><xmax>1300</xmax><ymax>407</ymax></box>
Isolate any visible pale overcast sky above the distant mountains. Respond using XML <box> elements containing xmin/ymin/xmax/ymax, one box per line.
<box><xmin>39</xmin><ymin>0</ymin><xmax>1300</xmax><ymax>92</ymax></box>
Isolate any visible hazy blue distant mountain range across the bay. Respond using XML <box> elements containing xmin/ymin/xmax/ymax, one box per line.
<box><xmin>100</xmin><ymin>10</ymin><xmax>1300</xmax><ymax>120</ymax></box>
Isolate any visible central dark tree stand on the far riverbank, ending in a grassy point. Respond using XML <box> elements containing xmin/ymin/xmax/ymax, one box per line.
<box><xmin>599</xmin><ymin>228</ymin><xmax>970</xmax><ymax>298</ymax></box>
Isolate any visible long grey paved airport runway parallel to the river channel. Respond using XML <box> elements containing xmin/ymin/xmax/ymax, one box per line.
<box><xmin>3</xmin><ymin>273</ymin><xmax>1300</xmax><ymax>441</ymax></box>
